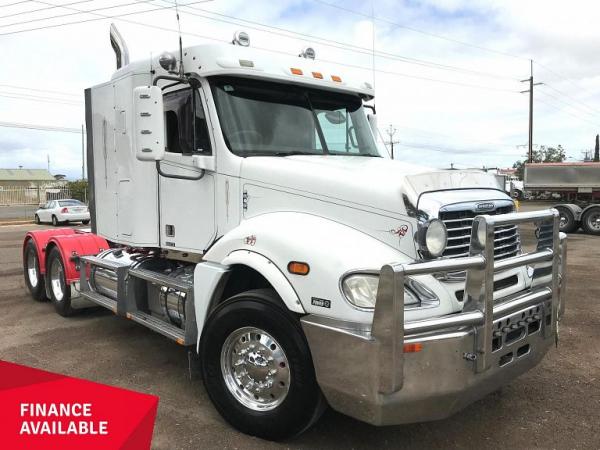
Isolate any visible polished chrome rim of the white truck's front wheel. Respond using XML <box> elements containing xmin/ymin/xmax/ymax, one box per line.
<box><xmin>221</xmin><ymin>327</ymin><xmax>291</xmax><ymax>411</ymax></box>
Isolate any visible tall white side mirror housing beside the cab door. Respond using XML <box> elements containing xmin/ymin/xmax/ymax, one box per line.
<box><xmin>133</xmin><ymin>86</ymin><xmax>165</xmax><ymax>161</ymax></box>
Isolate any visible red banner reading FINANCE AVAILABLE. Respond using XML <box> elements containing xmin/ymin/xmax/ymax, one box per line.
<box><xmin>0</xmin><ymin>361</ymin><xmax>158</xmax><ymax>450</ymax></box>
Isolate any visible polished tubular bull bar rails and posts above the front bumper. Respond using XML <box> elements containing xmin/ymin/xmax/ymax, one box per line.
<box><xmin>371</xmin><ymin>209</ymin><xmax>567</xmax><ymax>394</ymax></box>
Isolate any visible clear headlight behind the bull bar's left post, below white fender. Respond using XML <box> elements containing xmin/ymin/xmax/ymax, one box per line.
<box><xmin>340</xmin><ymin>271</ymin><xmax>440</xmax><ymax>312</ymax></box>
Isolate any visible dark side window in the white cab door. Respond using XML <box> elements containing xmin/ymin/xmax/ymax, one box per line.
<box><xmin>164</xmin><ymin>89</ymin><xmax>211</xmax><ymax>155</ymax></box>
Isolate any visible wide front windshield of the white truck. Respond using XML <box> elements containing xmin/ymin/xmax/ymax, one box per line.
<box><xmin>210</xmin><ymin>77</ymin><xmax>381</xmax><ymax>156</ymax></box>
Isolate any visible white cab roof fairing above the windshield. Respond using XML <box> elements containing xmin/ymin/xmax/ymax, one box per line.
<box><xmin>111</xmin><ymin>44</ymin><xmax>375</xmax><ymax>101</ymax></box>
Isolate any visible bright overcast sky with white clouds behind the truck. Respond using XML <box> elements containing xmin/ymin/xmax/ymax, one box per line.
<box><xmin>0</xmin><ymin>0</ymin><xmax>600</xmax><ymax>178</ymax></box>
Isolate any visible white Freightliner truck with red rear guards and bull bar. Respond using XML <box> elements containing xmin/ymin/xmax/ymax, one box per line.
<box><xmin>23</xmin><ymin>28</ymin><xmax>566</xmax><ymax>440</ymax></box>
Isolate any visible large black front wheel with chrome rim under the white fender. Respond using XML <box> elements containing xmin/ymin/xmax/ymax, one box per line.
<box><xmin>200</xmin><ymin>289</ymin><xmax>325</xmax><ymax>440</ymax></box>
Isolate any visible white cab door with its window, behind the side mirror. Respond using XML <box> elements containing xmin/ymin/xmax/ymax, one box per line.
<box><xmin>159</xmin><ymin>87</ymin><xmax>216</xmax><ymax>253</ymax></box>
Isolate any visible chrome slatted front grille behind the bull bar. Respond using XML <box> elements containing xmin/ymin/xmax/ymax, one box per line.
<box><xmin>439</xmin><ymin>205</ymin><xmax>521</xmax><ymax>260</ymax></box>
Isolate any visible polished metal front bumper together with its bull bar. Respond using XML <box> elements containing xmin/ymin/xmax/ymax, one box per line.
<box><xmin>302</xmin><ymin>210</ymin><xmax>566</xmax><ymax>425</ymax></box>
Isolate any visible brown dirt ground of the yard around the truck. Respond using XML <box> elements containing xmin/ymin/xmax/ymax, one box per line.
<box><xmin>0</xmin><ymin>202</ymin><xmax>600</xmax><ymax>449</ymax></box>
